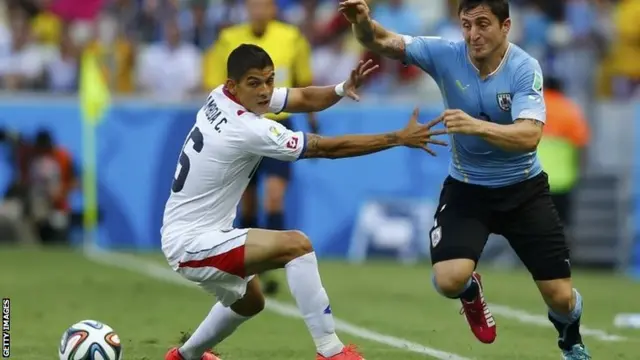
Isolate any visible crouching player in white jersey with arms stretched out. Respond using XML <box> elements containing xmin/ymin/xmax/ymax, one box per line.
<box><xmin>162</xmin><ymin>45</ymin><xmax>446</xmax><ymax>360</ymax></box>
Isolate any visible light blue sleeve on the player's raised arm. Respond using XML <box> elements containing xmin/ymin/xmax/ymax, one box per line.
<box><xmin>402</xmin><ymin>35</ymin><xmax>455</xmax><ymax>76</ymax></box>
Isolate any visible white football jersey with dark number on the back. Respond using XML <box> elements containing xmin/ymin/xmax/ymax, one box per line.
<box><xmin>161</xmin><ymin>86</ymin><xmax>305</xmax><ymax>253</ymax></box>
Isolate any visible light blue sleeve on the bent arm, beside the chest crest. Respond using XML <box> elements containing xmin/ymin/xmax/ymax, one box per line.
<box><xmin>511</xmin><ymin>59</ymin><xmax>547</xmax><ymax>122</ymax></box>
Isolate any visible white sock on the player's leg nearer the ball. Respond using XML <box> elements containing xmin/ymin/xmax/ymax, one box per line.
<box><xmin>179</xmin><ymin>303</ymin><xmax>250</xmax><ymax>360</ymax></box>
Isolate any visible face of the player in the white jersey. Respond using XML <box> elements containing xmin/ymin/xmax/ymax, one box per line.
<box><xmin>227</xmin><ymin>67</ymin><xmax>275</xmax><ymax>115</ymax></box>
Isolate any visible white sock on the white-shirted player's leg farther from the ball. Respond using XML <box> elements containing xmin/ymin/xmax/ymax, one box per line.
<box><xmin>285</xmin><ymin>252</ymin><xmax>344</xmax><ymax>357</ymax></box>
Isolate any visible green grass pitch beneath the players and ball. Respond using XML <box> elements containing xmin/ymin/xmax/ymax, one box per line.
<box><xmin>0</xmin><ymin>248</ymin><xmax>640</xmax><ymax>360</ymax></box>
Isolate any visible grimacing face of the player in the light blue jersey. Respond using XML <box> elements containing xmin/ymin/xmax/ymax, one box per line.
<box><xmin>460</xmin><ymin>5</ymin><xmax>511</xmax><ymax>60</ymax></box>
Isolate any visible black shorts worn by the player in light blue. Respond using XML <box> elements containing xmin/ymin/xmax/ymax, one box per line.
<box><xmin>429</xmin><ymin>172</ymin><xmax>571</xmax><ymax>280</ymax></box>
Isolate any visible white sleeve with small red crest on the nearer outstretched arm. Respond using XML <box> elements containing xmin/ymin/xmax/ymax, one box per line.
<box><xmin>244</xmin><ymin>118</ymin><xmax>306</xmax><ymax>161</ymax></box>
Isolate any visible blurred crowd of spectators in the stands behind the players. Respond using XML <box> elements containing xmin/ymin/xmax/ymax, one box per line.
<box><xmin>0</xmin><ymin>0</ymin><xmax>640</xmax><ymax>103</ymax></box>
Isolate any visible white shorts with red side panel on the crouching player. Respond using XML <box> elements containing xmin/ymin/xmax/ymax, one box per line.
<box><xmin>177</xmin><ymin>229</ymin><xmax>254</xmax><ymax>307</ymax></box>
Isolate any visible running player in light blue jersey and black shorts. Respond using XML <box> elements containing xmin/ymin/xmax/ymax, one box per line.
<box><xmin>339</xmin><ymin>0</ymin><xmax>591</xmax><ymax>359</ymax></box>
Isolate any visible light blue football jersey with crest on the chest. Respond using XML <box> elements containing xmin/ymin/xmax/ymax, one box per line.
<box><xmin>404</xmin><ymin>36</ymin><xmax>546</xmax><ymax>187</ymax></box>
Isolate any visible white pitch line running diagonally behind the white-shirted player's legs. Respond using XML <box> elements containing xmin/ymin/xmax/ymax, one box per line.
<box><xmin>85</xmin><ymin>250</ymin><xmax>471</xmax><ymax>360</ymax></box>
